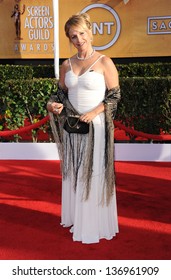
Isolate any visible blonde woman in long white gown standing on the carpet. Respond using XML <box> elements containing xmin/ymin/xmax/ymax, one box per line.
<box><xmin>48</xmin><ymin>14</ymin><xmax>120</xmax><ymax>244</ymax></box>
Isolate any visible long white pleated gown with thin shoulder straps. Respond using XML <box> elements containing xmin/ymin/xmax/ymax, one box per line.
<box><xmin>61</xmin><ymin>58</ymin><xmax>118</xmax><ymax>244</ymax></box>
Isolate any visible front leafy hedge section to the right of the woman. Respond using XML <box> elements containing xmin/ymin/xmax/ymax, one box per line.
<box><xmin>117</xmin><ymin>77</ymin><xmax>171</xmax><ymax>134</ymax></box>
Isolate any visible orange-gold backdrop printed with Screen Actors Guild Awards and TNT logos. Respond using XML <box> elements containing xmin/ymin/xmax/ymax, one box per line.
<box><xmin>0</xmin><ymin>0</ymin><xmax>171</xmax><ymax>59</ymax></box>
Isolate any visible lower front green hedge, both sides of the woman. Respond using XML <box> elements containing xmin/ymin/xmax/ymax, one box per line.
<box><xmin>0</xmin><ymin>77</ymin><xmax>171</xmax><ymax>141</ymax></box>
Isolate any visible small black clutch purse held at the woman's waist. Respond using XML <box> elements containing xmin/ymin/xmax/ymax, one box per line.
<box><xmin>63</xmin><ymin>115</ymin><xmax>89</xmax><ymax>134</ymax></box>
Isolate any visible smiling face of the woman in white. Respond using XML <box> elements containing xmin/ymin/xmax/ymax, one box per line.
<box><xmin>69</xmin><ymin>27</ymin><xmax>91</xmax><ymax>51</ymax></box>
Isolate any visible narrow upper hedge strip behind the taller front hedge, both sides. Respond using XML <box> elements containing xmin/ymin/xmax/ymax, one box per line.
<box><xmin>0</xmin><ymin>63</ymin><xmax>171</xmax><ymax>80</ymax></box>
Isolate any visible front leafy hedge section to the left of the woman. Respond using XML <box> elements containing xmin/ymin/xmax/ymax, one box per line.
<box><xmin>0</xmin><ymin>79</ymin><xmax>57</xmax><ymax>142</ymax></box>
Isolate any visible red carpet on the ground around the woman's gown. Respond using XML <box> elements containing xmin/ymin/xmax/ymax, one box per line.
<box><xmin>0</xmin><ymin>160</ymin><xmax>171</xmax><ymax>260</ymax></box>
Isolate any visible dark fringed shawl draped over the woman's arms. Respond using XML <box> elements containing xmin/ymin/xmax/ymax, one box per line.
<box><xmin>48</xmin><ymin>86</ymin><xmax>120</xmax><ymax>204</ymax></box>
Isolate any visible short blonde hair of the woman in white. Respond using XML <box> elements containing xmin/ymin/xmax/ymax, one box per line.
<box><xmin>64</xmin><ymin>13</ymin><xmax>92</xmax><ymax>39</ymax></box>
